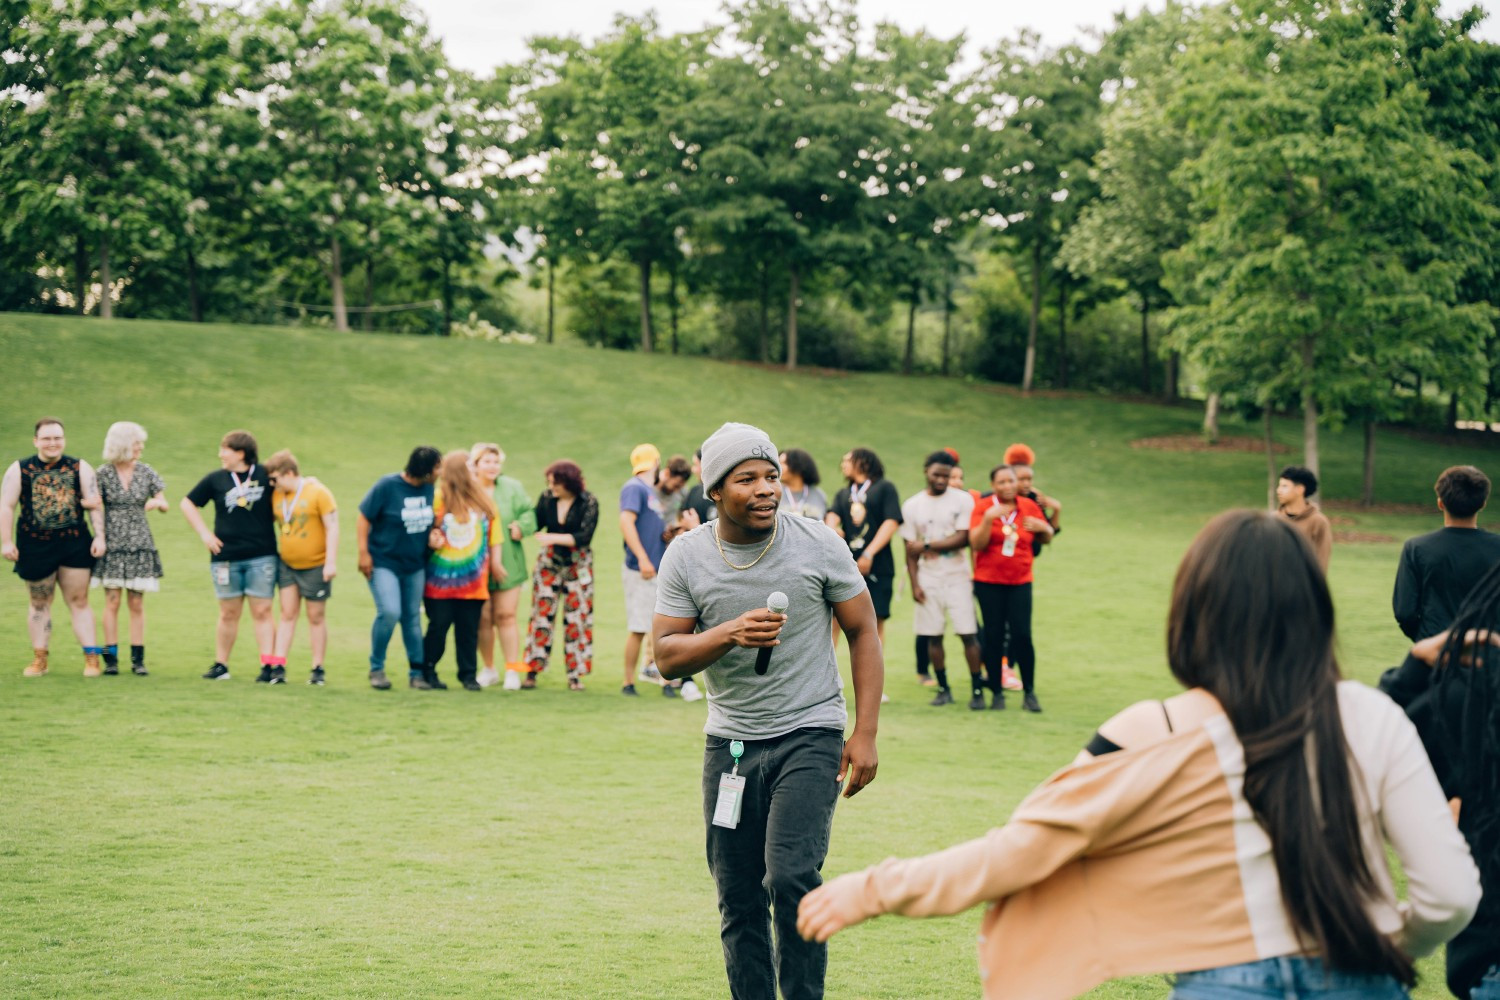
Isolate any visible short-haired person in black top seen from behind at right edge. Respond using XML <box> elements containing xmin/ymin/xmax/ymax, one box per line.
<box><xmin>1391</xmin><ymin>465</ymin><xmax>1500</xmax><ymax>640</ymax></box>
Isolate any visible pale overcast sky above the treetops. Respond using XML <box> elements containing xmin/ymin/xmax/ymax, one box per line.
<box><xmin>414</xmin><ymin>0</ymin><xmax>1500</xmax><ymax>73</ymax></box>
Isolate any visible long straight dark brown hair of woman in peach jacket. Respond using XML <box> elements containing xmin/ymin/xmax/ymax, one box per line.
<box><xmin>1167</xmin><ymin>510</ymin><xmax>1416</xmax><ymax>985</ymax></box>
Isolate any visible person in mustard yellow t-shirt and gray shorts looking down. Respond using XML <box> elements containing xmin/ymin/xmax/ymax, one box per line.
<box><xmin>271</xmin><ymin>451</ymin><xmax>339</xmax><ymax>687</ymax></box>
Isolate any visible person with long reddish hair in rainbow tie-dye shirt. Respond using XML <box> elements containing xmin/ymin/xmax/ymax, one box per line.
<box><xmin>423</xmin><ymin>451</ymin><xmax>506</xmax><ymax>691</ymax></box>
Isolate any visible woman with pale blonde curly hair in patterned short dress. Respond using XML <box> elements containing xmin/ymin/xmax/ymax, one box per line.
<box><xmin>93</xmin><ymin>420</ymin><xmax>167</xmax><ymax>678</ymax></box>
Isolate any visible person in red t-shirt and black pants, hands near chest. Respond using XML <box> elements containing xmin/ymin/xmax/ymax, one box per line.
<box><xmin>969</xmin><ymin>465</ymin><xmax>1052</xmax><ymax>712</ymax></box>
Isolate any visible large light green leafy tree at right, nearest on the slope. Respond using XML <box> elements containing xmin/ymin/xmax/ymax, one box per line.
<box><xmin>1166</xmin><ymin>0</ymin><xmax>1494</xmax><ymax>471</ymax></box>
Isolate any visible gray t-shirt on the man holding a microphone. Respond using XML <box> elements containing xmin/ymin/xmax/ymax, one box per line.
<box><xmin>657</xmin><ymin>513</ymin><xmax>866</xmax><ymax>739</ymax></box>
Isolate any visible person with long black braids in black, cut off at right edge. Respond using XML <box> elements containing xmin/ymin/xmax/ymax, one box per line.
<box><xmin>1380</xmin><ymin>565</ymin><xmax>1500</xmax><ymax>1000</ymax></box>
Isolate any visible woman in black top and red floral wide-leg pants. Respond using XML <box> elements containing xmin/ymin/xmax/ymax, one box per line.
<box><xmin>521</xmin><ymin>460</ymin><xmax>599</xmax><ymax>691</ymax></box>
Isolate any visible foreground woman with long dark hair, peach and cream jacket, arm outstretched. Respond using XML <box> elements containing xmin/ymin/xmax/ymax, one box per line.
<box><xmin>798</xmin><ymin>511</ymin><xmax>1479</xmax><ymax>1000</ymax></box>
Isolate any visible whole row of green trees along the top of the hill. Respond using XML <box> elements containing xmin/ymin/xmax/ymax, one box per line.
<box><xmin>0</xmin><ymin>0</ymin><xmax>1500</xmax><ymax>488</ymax></box>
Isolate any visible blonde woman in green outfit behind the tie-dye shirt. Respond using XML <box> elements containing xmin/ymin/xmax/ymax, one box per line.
<box><xmin>470</xmin><ymin>441</ymin><xmax>537</xmax><ymax>691</ymax></box>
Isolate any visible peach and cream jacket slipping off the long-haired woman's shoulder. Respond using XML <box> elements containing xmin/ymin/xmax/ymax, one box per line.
<box><xmin>858</xmin><ymin>681</ymin><xmax>1479</xmax><ymax>1000</ymax></box>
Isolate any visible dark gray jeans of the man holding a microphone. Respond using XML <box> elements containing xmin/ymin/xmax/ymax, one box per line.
<box><xmin>704</xmin><ymin>729</ymin><xmax>843</xmax><ymax>1000</ymax></box>
